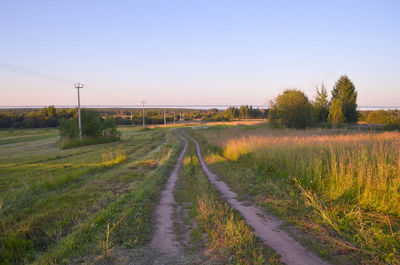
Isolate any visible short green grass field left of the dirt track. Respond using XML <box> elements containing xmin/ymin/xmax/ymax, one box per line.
<box><xmin>0</xmin><ymin>125</ymin><xmax>178</xmax><ymax>264</ymax></box>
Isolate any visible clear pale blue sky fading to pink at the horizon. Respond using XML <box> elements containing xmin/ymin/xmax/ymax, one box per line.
<box><xmin>0</xmin><ymin>0</ymin><xmax>400</xmax><ymax>106</ymax></box>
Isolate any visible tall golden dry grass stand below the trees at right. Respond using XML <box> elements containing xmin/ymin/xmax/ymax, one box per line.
<box><xmin>223</xmin><ymin>132</ymin><xmax>400</xmax><ymax>217</ymax></box>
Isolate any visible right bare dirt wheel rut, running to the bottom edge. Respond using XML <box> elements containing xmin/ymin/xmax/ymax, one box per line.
<box><xmin>183</xmin><ymin>132</ymin><xmax>329</xmax><ymax>265</ymax></box>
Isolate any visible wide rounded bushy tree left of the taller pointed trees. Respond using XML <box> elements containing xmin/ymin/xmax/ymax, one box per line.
<box><xmin>268</xmin><ymin>89</ymin><xmax>312</xmax><ymax>129</ymax></box>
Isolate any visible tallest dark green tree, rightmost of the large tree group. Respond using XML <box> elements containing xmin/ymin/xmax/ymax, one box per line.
<box><xmin>332</xmin><ymin>75</ymin><xmax>358</xmax><ymax>122</ymax></box>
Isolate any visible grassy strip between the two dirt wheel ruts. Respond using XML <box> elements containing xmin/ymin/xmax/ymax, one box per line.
<box><xmin>175</xmin><ymin>138</ymin><xmax>280</xmax><ymax>264</ymax></box>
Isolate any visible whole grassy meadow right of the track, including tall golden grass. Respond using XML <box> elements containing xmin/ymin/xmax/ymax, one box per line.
<box><xmin>192</xmin><ymin>125</ymin><xmax>400</xmax><ymax>264</ymax></box>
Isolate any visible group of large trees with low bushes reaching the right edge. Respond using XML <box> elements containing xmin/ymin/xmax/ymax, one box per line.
<box><xmin>269</xmin><ymin>75</ymin><xmax>400</xmax><ymax>130</ymax></box>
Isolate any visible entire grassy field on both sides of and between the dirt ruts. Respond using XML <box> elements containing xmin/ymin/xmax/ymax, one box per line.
<box><xmin>0</xmin><ymin>122</ymin><xmax>400</xmax><ymax>264</ymax></box>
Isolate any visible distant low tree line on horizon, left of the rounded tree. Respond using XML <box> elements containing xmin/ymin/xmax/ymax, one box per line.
<box><xmin>0</xmin><ymin>105</ymin><xmax>267</xmax><ymax>129</ymax></box>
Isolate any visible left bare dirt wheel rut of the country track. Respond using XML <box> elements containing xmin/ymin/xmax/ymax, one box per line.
<box><xmin>150</xmin><ymin>134</ymin><xmax>188</xmax><ymax>255</ymax></box>
